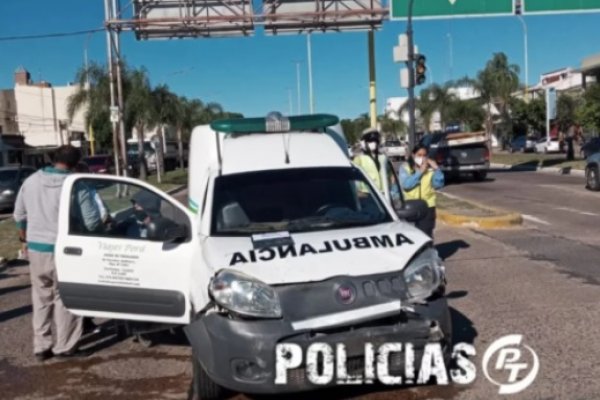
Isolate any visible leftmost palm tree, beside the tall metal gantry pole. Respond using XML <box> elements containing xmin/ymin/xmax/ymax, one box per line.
<box><xmin>67</xmin><ymin>63</ymin><xmax>113</xmax><ymax>152</ymax></box>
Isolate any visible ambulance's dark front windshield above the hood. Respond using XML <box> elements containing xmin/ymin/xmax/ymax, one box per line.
<box><xmin>212</xmin><ymin>168</ymin><xmax>392</xmax><ymax>236</ymax></box>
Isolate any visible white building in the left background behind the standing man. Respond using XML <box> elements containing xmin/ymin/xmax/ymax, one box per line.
<box><xmin>0</xmin><ymin>68</ymin><xmax>86</xmax><ymax>147</ymax></box>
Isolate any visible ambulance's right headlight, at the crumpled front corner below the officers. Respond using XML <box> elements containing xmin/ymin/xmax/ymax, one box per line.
<box><xmin>402</xmin><ymin>248</ymin><xmax>444</xmax><ymax>302</ymax></box>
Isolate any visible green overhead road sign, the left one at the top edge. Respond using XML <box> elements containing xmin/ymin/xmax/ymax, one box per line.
<box><xmin>390</xmin><ymin>0</ymin><xmax>512</xmax><ymax>20</ymax></box>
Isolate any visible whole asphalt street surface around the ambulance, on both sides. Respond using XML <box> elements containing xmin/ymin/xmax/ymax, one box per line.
<box><xmin>0</xmin><ymin>180</ymin><xmax>600</xmax><ymax>400</ymax></box>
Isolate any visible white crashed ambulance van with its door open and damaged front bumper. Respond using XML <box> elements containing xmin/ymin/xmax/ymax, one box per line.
<box><xmin>56</xmin><ymin>113</ymin><xmax>451</xmax><ymax>399</ymax></box>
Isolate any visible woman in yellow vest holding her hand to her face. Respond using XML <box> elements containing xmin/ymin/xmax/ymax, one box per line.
<box><xmin>400</xmin><ymin>145</ymin><xmax>444</xmax><ymax>238</ymax></box>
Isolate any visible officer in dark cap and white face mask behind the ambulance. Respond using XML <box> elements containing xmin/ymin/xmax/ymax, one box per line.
<box><xmin>354</xmin><ymin>128</ymin><xmax>388</xmax><ymax>192</ymax></box>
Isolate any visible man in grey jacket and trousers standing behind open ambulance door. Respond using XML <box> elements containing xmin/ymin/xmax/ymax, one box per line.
<box><xmin>13</xmin><ymin>145</ymin><xmax>95</xmax><ymax>361</ymax></box>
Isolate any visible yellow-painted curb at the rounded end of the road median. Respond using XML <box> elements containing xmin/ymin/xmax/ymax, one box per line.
<box><xmin>437</xmin><ymin>193</ymin><xmax>523</xmax><ymax>229</ymax></box>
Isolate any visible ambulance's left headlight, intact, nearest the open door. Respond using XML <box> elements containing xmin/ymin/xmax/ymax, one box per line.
<box><xmin>208</xmin><ymin>269</ymin><xmax>281</xmax><ymax>318</ymax></box>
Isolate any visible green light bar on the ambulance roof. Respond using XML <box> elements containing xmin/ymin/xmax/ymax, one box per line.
<box><xmin>210</xmin><ymin>112</ymin><xmax>340</xmax><ymax>133</ymax></box>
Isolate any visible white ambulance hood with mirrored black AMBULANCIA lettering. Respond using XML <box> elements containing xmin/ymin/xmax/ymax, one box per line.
<box><xmin>202</xmin><ymin>221</ymin><xmax>431</xmax><ymax>284</ymax></box>
